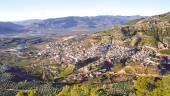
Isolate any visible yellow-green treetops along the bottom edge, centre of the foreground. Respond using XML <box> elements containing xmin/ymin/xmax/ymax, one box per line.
<box><xmin>57</xmin><ymin>82</ymin><xmax>131</xmax><ymax>96</ymax></box>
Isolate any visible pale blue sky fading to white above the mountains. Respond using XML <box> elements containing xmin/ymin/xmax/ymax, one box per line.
<box><xmin>0</xmin><ymin>0</ymin><xmax>170</xmax><ymax>21</ymax></box>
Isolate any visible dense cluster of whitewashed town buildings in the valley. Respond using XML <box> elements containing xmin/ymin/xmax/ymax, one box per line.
<box><xmin>34</xmin><ymin>36</ymin><xmax>159</xmax><ymax>81</ymax></box>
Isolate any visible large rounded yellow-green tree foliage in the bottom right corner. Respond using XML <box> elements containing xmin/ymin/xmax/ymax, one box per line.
<box><xmin>130</xmin><ymin>75</ymin><xmax>170</xmax><ymax>96</ymax></box>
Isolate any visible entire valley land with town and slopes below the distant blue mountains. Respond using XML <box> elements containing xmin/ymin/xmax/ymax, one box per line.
<box><xmin>0</xmin><ymin>13</ymin><xmax>170</xmax><ymax>96</ymax></box>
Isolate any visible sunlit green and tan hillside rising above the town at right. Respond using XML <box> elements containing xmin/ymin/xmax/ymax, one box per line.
<box><xmin>122</xmin><ymin>13</ymin><xmax>170</xmax><ymax>49</ymax></box>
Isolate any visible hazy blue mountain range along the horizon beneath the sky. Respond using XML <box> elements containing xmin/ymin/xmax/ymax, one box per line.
<box><xmin>0</xmin><ymin>15</ymin><xmax>143</xmax><ymax>34</ymax></box>
